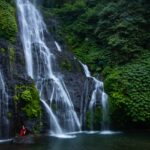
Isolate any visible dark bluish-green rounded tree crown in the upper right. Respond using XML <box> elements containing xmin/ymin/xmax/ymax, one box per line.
<box><xmin>95</xmin><ymin>1</ymin><xmax>149</xmax><ymax>64</ymax></box>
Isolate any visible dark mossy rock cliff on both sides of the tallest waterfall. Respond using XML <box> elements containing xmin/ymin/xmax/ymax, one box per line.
<box><xmin>0</xmin><ymin>1</ymin><xmax>95</xmax><ymax>137</ymax></box>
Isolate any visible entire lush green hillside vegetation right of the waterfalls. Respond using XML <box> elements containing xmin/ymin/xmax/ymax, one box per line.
<box><xmin>43</xmin><ymin>0</ymin><xmax>150</xmax><ymax>128</ymax></box>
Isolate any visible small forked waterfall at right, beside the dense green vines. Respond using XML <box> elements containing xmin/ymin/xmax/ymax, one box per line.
<box><xmin>80</xmin><ymin>62</ymin><xmax>108</xmax><ymax>130</ymax></box>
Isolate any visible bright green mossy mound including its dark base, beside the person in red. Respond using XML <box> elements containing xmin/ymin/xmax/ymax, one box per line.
<box><xmin>13</xmin><ymin>84</ymin><xmax>42</xmax><ymax>133</ymax></box>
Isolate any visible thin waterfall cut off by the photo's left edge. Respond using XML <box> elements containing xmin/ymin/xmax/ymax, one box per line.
<box><xmin>0</xmin><ymin>71</ymin><xmax>9</xmax><ymax>138</ymax></box>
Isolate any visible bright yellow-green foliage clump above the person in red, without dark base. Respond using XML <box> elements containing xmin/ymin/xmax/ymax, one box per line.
<box><xmin>14</xmin><ymin>85</ymin><xmax>41</xmax><ymax>118</ymax></box>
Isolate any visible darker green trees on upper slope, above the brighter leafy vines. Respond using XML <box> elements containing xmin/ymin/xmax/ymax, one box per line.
<box><xmin>53</xmin><ymin>0</ymin><xmax>150</xmax><ymax>70</ymax></box>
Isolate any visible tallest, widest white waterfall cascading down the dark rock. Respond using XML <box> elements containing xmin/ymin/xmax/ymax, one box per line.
<box><xmin>16</xmin><ymin>0</ymin><xmax>80</xmax><ymax>134</ymax></box>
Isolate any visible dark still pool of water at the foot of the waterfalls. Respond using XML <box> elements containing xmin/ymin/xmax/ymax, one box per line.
<box><xmin>0</xmin><ymin>132</ymin><xmax>150</xmax><ymax>150</ymax></box>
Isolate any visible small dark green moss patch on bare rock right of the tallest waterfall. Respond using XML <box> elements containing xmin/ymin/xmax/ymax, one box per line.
<box><xmin>60</xmin><ymin>59</ymin><xmax>73</xmax><ymax>72</ymax></box>
